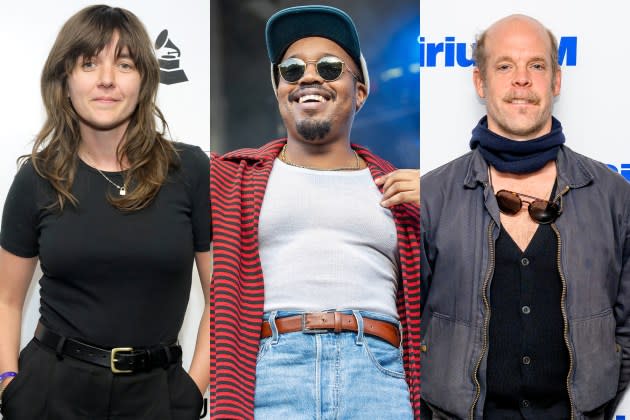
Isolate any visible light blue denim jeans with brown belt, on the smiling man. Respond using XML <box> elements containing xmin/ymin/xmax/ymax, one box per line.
<box><xmin>254</xmin><ymin>311</ymin><xmax>413</xmax><ymax>420</ymax></box>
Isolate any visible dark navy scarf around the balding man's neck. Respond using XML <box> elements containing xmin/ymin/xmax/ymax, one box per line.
<box><xmin>470</xmin><ymin>116</ymin><xmax>564</xmax><ymax>174</ymax></box>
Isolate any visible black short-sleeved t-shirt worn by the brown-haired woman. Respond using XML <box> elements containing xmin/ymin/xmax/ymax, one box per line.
<box><xmin>0</xmin><ymin>143</ymin><xmax>210</xmax><ymax>347</ymax></box>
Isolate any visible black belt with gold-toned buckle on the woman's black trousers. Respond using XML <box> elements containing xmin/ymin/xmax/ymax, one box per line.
<box><xmin>35</xmin><ymin>322</ymin><xmax>182</xmax><ymax>373</ymax></box>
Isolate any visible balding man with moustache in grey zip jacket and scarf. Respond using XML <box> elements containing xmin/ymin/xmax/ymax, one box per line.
<box><xmin>421</xmin><ymin>15</ymin><xmax>630</xmax><ymax>419</ymax></box>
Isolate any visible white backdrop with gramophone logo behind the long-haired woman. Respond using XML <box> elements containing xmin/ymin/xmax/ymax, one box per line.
<box><xmin>0</xmin><ymin>0</ymin><xmax>210</xmax><ymax>418</ymax></box>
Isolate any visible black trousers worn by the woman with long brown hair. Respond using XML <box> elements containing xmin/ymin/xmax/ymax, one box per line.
<box><xmin>2</xmin><ymin>339</ymin><xmax>203</xmax><ymax>420</ymax></box>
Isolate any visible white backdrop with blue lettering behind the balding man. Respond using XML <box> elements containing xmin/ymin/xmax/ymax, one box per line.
<box><xmin>418</xmin><ymin>0</ymin><xmax>630</xmax><ymax>420</ymax></box>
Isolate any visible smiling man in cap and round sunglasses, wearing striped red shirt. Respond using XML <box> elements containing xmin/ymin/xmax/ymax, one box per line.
<box><xmin>210</xmin><ymin>6</ymin><xmax>420</xmax><ymax>420</ymax></box>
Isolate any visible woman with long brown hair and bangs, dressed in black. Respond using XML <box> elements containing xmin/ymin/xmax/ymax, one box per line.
<box><xmin>0</xmin><ymin>6</ymin><xmax>210</xmax><ymax>420</ymax></box>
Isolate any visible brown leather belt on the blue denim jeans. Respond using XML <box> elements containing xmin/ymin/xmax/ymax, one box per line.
<box><xmin>260</xmin><ymin>312</ymin><xmax>400</xmax><ymax>347</ymax></box>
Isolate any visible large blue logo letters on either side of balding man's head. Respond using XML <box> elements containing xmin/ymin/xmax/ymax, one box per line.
<box><xmin>418</xmin><ymin>36</ymin><xmax>577</xmax><ymax>67</ymax></box>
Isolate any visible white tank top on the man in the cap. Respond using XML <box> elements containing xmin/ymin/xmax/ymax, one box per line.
<box><xmin>258</xmin><ymin>159</ymin><xmax>398</xmax><ymax>319</ymax></box>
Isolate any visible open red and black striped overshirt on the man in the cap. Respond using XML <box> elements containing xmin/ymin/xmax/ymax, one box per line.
<box><xmin>210</xmin><ymin>139</ymin><xmax>420</xmax><ymax>420</ymax></box>
